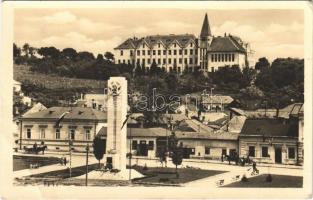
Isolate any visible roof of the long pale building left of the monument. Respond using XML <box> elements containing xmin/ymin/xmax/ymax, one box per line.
<box><xmin>22</xmin><ymin>107</ymin><xmax>107</xmax><ymax>120</ymax></box>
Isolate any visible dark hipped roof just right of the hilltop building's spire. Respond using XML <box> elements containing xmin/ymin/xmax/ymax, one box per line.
<box><xmin>209</xmin><ymin>36</ymin><xmax>245</xmax><ymax>53</ymax></box>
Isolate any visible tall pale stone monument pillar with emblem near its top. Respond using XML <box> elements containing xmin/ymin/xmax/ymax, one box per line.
<box><xmin>106</xmin><ymin>77</ymin><xmax>128</xmax><ymax>171</ymax></box>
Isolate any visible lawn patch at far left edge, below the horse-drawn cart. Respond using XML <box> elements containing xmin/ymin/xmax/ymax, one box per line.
<box><xmin>13</xmin><ymin>155</ymin><xmax>60</xmax><ymax>171</ymax></box>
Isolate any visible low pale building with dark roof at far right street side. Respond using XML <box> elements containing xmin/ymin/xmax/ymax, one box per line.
<box><xmin>239</xmin><ymin>118</ymin><xmax>301</xmax><ymax>164</ymax></box>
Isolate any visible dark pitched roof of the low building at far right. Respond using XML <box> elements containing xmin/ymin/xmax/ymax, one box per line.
<box><xmin>240</xmin><ymin>118</ymin><xmax>298</xmax><ymax>137</ymax></box>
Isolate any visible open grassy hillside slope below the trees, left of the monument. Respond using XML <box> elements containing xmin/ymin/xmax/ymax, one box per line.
<box><xmin>13</xmin><ymin>65</ymin><xmax>105</xmax><ymax>89</ymax></box>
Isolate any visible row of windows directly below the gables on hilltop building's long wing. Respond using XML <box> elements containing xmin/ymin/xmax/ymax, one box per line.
<box><xmin>120</xmin><ymin>49</ymin><xmax>198</xmax><ymax>56</ymax></box>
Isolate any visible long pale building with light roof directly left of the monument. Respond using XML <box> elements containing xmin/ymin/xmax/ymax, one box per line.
<box><xmin>19</xmin><ymin>107</ymin><xmax>107</xmax><ymax>152</ymax></box>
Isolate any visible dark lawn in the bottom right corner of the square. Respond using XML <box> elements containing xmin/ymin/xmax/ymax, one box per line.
<box><xmin>224</xmin><ymin>174</ymin><xmax>303</xmax><ymax>188</ymax></box>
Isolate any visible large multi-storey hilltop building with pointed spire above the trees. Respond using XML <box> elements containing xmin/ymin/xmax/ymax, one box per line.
<box><xmin>114</xmin><ymin>14</ymin><xmax>253</xmax><ymax>73</ymax></box>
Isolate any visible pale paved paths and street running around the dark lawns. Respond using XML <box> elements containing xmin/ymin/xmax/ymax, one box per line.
<box><xmin>13</xmin><ymin>153</ymin><xmax>303</xmax><ymax>187</ymax></box>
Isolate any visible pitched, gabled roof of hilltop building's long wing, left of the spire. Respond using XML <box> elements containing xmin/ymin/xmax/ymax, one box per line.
<box><xmin>115</xmin><ymin>34</ymin><xmax>196</xmax><ymax>49</ymax></box>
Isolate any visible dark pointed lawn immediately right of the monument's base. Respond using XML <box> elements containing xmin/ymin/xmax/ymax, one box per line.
<box><xmin>133</xmin><ymin>166</ymin><xmax>226</xmax><ymax>184</ymax></box>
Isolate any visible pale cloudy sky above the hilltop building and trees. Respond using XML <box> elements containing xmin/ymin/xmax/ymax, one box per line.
<box><xmin>14</xmin><ymin>8</ymin><xmax>304</xmax><ymax>60</ymax></box>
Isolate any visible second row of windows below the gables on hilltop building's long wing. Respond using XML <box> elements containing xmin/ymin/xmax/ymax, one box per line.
<box><xmin>117</xmin><ymin>58</ymin><xmax>198</xmax><ymax>65</ymax></box>
